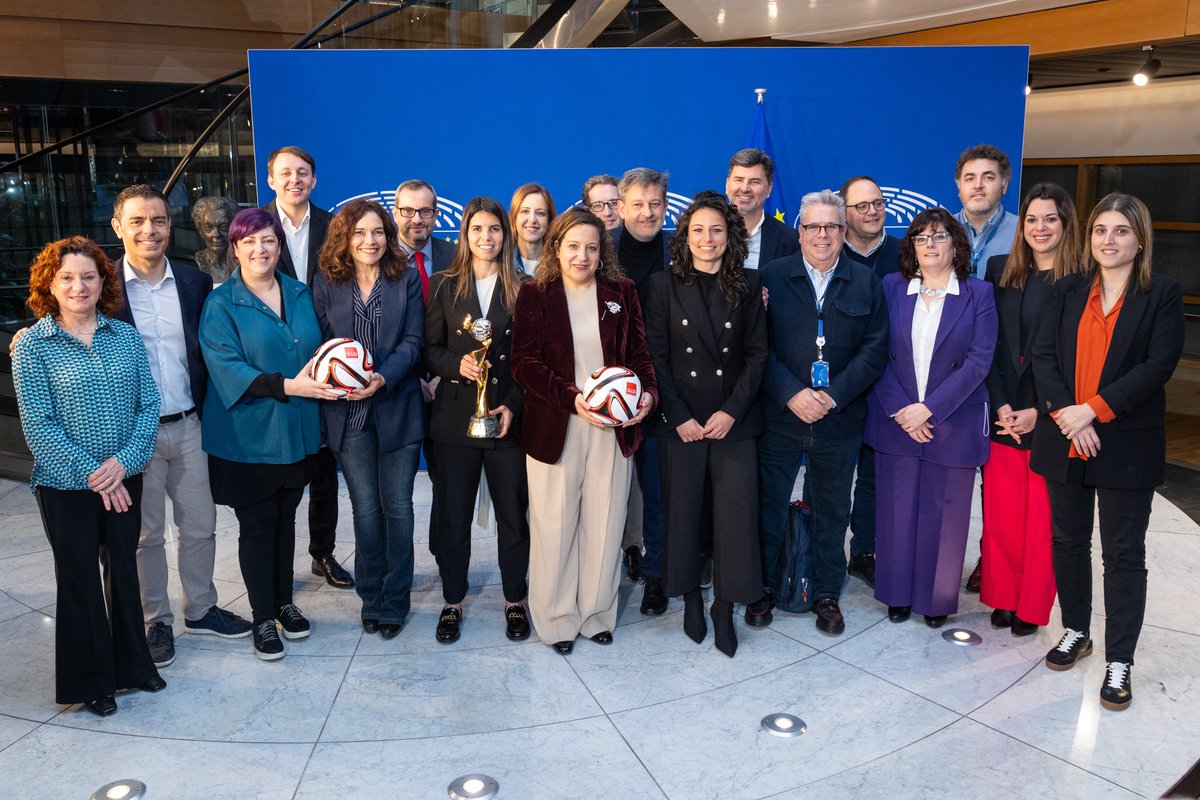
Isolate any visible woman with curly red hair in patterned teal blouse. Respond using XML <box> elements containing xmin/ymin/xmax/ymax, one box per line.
<box><xmin>12</xmin><ymin>236</ymin><xmax>167</xmax><ymax>716</ymax></box>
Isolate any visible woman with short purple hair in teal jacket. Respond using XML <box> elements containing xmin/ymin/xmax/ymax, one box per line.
<box><xmin>200</xmin><ymin>209</ymin><xmax>340</xmax><ymax>661</ymax></box>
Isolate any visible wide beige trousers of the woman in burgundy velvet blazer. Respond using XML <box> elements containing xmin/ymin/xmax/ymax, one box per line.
<box><xmin>526</xmin><ymin>415</ymin><xmax>632</xmax><ymax>644</ymax></box>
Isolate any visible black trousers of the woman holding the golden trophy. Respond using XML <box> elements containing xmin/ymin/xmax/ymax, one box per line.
<box><xmin>425</xmin><ymin>439</ymin><xmax>529</xmax><ymax>604</ymax></box>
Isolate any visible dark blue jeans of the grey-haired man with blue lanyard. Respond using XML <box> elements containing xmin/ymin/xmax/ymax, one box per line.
<box><xmin>758</xmin><ymin>429</ymin><xmax>862</xmax><ymax>600</ymax></box>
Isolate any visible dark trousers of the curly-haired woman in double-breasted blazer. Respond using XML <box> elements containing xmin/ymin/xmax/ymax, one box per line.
<box><xmin>659</xmin><ymin>433</ymin><xmax>762</xmax><ymax>603</ymax></box>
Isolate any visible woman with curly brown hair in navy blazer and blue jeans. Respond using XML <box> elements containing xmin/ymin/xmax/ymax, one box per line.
<box><xmin>313</xmin><ymin>200</ymin><xmax>425</xmax><ymax>639</ymax></box>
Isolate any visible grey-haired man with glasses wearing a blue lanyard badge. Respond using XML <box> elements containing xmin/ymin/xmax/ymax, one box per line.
<box><xmin>746</xmin><ymin>190</ymin><xmax>888</xmax><ymax>636</ymax></box>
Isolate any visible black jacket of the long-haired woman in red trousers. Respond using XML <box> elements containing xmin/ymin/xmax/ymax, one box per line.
<box><xmin>986</xmin><ymin>255</ymin><xmax>1050</xmax><ymax>450</ymax></box>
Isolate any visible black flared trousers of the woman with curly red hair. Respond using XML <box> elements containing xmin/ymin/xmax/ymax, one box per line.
<box><xmin>37</xmin><ymin>475</ymin><xmax>158</xmax><ymax>703</ymax></box>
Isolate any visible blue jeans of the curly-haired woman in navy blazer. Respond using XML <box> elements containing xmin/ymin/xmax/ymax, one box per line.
<box><xmin>337</xmin><ymin>422</ymin><xmax>421</xmax><ymax>625</ymax></box>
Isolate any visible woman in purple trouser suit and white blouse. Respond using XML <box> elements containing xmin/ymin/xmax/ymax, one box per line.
<box><xmin>865</xmin><ymin>209</ymin><xmax>997</xmax><ymax>627</ymax></box>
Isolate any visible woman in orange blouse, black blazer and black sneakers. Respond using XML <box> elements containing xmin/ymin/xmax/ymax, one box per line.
<box><xmin>1031</xmin><ymin>192</ymin><xmax>1183</xmax><ymax>710</ymax></box>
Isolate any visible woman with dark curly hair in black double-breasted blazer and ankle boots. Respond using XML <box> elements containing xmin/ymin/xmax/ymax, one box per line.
<box><xmin>646</xmin><ymin>192</ymin><xmax>767</xmax><ymax>656</ymax></box>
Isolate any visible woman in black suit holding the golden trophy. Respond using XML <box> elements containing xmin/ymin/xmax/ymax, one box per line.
<box><xmin>425</xmin><ymin>197</ymin><xmax>529</xmax><ymax>644</ymax></box>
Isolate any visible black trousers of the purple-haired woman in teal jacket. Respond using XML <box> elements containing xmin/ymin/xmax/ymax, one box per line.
<box><xmin>233</xmin><ymin>488</ymin><xmax>304</xmax><ymax>625</ymax></box>
